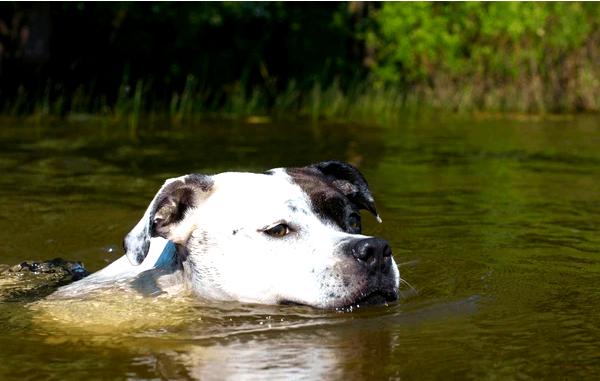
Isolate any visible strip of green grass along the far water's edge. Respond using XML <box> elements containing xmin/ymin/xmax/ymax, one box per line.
<box><xmin>4</xmin><ymin>69</ymin><xmax>600</xmax><ymax>132</ymax></box>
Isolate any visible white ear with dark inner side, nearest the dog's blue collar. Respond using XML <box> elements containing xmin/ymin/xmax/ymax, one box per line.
<box><xmin>123</xmin><ymin>174</ymin><xmax>213</xmax><ymax>265</ymax></box>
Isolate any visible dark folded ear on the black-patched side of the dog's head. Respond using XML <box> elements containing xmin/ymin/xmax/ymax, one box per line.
<box><xmin>311</xmin><ymin>160</ymin><xmax>381</xmax><ymax>222</ymax></box>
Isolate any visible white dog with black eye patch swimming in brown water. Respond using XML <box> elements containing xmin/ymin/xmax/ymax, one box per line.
<box><xmin>51</xmin><ymin>161</ymin><xmax>400</xmax><ymax>309</ymax></box>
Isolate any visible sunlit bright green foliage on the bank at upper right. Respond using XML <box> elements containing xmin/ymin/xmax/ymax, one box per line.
<box><xmin>368</xmin><ymin>2</ymin><xmax>600</xmax><ymax>111</ymax></box>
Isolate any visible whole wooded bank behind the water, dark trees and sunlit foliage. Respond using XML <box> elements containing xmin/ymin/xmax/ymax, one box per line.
<box><xmin>0</xmin><ymin>2</ymin><xmax>600</xmax><ymax>118</ymax></box>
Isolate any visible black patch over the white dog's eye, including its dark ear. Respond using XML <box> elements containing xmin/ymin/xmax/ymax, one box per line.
<box><xmin>286</xmin><ymin>161</ymin><xmax>377</xmax><ymax>233</ymax></box>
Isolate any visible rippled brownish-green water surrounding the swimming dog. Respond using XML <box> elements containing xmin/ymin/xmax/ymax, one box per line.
<box><xmin>0</xmin><ymin>117</ymin><xmax>600</xmax><ymax>380</ymax></box>
